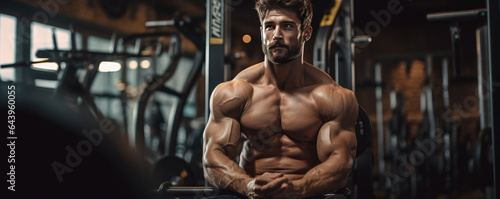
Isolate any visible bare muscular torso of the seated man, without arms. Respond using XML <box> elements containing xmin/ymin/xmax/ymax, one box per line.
<box><xmin>229</xmin><ymin>64</ymin><xmax>335</xmax><ymax>179</ymax></box>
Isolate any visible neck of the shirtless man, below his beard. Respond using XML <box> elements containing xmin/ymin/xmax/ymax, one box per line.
<box><xmin>264</xmin><ymin>57</ymin><xmax>304</xmax><ymax>91</ymax></box>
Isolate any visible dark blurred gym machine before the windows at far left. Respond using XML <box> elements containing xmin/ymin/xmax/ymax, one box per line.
<box><xmin>2</xmin><ymin>25</ymin><xmax>140</xmax><ymax>126</ymax></box>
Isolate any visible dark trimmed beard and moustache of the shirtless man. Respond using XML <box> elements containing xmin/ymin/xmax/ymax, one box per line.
<box><xmin>262</xmin><ymin>42</ymin><xmax>300</xmax><ymax>64</ymax></box>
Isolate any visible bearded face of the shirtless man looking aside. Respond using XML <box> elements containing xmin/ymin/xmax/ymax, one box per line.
<box><xmin>261</xmin><ymin>9</ymin><xmax>310</xmax><ymax>64</ymax></box>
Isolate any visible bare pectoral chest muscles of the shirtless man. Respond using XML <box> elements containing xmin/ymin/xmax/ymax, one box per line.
<box><xmin>240</xmin><ymin>87</ymin><xmax>323</xmax><ymax>141</ymax></box>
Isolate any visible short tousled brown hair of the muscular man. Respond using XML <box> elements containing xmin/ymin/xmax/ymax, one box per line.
<box><xmin>255</xmin><ymin>0</ymin><xmax>313</xmax><ymax>30</ymax></box>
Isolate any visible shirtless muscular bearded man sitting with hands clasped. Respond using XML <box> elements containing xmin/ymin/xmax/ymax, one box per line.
<box><xmin>203</xmin><ymin>0</ymin><xmax>358</xmax><ymax>198</ymax></box>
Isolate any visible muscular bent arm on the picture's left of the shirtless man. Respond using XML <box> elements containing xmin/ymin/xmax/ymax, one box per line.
<box><xmin>203</xmin><ymin>81</ymin><xmax>252</xmax><ymax>195</ymax></box>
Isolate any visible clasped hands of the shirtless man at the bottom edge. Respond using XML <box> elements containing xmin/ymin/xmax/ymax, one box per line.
<box><xmin>247</xmin><ymin>172</ymin><xmax>298</xmax><ymax>199</ymax></box>
